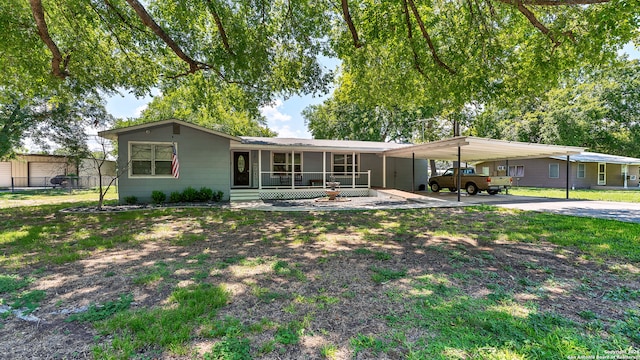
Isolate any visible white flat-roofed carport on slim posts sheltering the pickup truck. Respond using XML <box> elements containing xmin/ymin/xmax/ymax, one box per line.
<box><xmin>383</xmin><ymin>136</ymin><xmax>586</xmax><ymax>201</ymax></box>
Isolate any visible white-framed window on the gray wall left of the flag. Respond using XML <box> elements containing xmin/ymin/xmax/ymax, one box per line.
<box><xmin>129</xmin><ymin>143</ymin><xmax>173</xmax><ymax>176</ymax></box>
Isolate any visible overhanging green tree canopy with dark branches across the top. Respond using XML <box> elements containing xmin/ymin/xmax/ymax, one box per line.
<box><xmin>0</xmin><ymin>0</ymin><xmax>640</xmax><ymax>153</ymax></box>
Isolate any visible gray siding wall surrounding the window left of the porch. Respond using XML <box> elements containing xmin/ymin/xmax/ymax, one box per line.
<box><xmin>118</xmin><ymin>124</ymin><xmax>231</xmax><ymax>202</ymax></box>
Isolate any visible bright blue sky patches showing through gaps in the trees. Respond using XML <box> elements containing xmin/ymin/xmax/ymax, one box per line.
<box><xmin>107</xmin><ymin>44</ymin><xmax>640</xmax><ymax>138</ymax></box>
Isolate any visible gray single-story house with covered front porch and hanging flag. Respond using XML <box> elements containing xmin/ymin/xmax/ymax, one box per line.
<box><xmin>100</xmin><ymin>120</ymin><xmax>427</xmax><ymax>201</ymax></box>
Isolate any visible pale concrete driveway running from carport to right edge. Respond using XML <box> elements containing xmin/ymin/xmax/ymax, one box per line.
<box><xmin>422</xmin><ymin>192</ymin><xmax>640</xmax><ymax>223</ymax></box>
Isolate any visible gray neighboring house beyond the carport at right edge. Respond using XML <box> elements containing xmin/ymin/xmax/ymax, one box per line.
<box><xmin>476</xmin><ymin>152</ymin><xmax>640</xmax><ymax>189</ymax></box>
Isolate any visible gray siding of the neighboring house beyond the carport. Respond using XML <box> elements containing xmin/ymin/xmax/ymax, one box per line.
<box><xmin>476</xmin><ymin>159</ymin><xmax>638</xmax><ymax>189</ymax></box>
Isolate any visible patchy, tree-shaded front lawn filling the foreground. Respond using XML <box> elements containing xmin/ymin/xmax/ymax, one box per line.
<box><xmin>0</xmin><ymin>205</ymin><xmax>640</xmax><ymax>359</ymax></box>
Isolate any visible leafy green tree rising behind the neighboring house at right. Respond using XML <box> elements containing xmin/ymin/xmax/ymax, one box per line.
<box><xmin>472</xmin><ymin>60</ymin><xmax>640</xmax><ymax>157</ymax></box>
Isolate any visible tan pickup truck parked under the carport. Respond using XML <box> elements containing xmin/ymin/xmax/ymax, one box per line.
<box><xmin>429</xmin><ymin>168</ymin><xmax>513</xmax><ymax>195</ymax></box>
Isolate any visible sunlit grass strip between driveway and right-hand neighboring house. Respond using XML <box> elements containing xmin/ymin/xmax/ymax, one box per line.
<box><xmin>509</xmin><ymin>187</ymin><xmax>640</xmax><ymax>203</ymax></box>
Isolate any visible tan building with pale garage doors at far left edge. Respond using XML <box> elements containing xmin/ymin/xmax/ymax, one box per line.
<box><xmin>0</xmin><ymin>154</ymin><xmax>115</xmax><ymax>188</ymax></box>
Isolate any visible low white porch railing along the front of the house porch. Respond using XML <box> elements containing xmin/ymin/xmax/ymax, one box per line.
<box><xmin>259</xmin><ymin>170</ymin><xmax>371</xmax><ymax>189</ymax></box>
